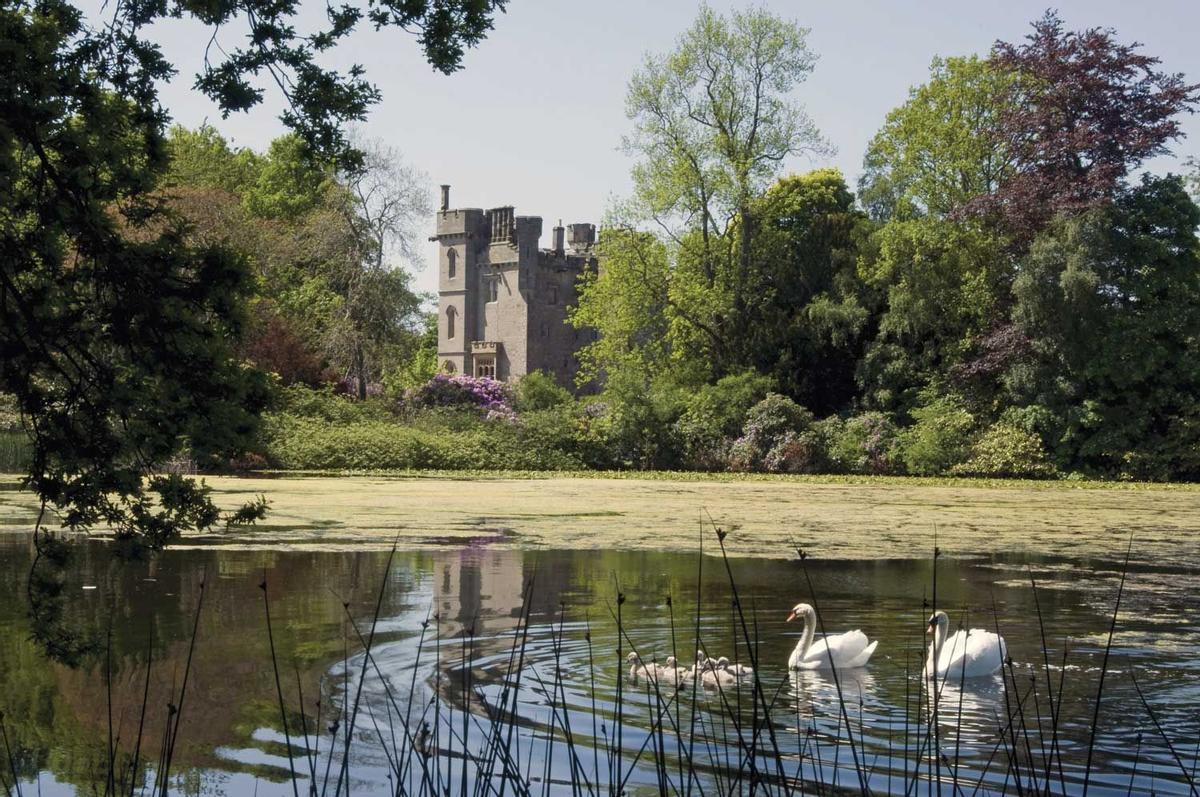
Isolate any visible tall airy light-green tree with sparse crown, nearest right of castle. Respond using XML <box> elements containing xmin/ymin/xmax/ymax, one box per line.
<box><xmin>625</xmin><ymin>6</ymin><xmax>827</xmax><ymax>373</ymax></box>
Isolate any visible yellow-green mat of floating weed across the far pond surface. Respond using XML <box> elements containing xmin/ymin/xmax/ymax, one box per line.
<box><xmin>0</xmin><ymin>474</ymin><xmax>1200</xmax><ymax>568</ymax></box>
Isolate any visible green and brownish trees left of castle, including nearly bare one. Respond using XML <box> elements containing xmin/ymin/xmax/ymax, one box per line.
<box><xmin>163</xmin><ymin>127</ymin><xmax>433</xmax><ymax>400</ymax></box>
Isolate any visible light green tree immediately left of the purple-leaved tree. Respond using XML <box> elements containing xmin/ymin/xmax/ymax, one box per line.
<box><xmin>858</xmin><ymin>58</ymin><xmax>1016</xmax><ymax>412</ymax></box>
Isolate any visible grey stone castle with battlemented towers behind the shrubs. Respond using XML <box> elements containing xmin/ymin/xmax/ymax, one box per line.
<box><xmin>431</xmin><ymin>185</ymin><xmax>596</xmax><ymax>390</ymax></box>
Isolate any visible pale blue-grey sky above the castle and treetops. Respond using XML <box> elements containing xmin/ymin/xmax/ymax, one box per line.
<box><xmin>121</xmin><ymin>0</ymin><xmax>1200</xmax><ymax>290</ymax></box>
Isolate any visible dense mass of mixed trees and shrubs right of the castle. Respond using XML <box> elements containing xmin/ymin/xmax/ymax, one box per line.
<box><xmin>574</xmin><ymin>10</ymin><xmax>1200</xmax><ymax>479</ymax></box>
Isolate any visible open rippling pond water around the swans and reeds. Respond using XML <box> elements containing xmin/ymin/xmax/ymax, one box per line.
<box><xmin>0</xmin><ymin>535</ymin><xmax>1200</xmax><ymax>796</ymax></box>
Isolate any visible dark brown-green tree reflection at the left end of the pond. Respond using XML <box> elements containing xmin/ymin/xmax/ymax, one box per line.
<box><xmin>0</xmin><ymin>543</ymin><xmax>430</xmax><ymax>787</ymax></box>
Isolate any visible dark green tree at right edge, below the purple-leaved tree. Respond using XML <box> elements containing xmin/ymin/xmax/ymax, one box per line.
<box><xmin>1009</xmin><ymin>178</ymin><xmax>1200</xmax><ymax>479</ymax></box>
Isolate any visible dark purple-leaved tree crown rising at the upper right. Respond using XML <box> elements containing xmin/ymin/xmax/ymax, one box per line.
<box><xmin>974</xmin><ymin>12</ymin><xmax>1200</xmax><ymax>241</ymax></box>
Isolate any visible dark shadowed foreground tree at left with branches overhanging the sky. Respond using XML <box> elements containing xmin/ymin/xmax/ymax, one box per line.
<box><xmin>0</xmin><ymin>0</ymin><xmax>504</xmax><ymax>546</ymax></box>
